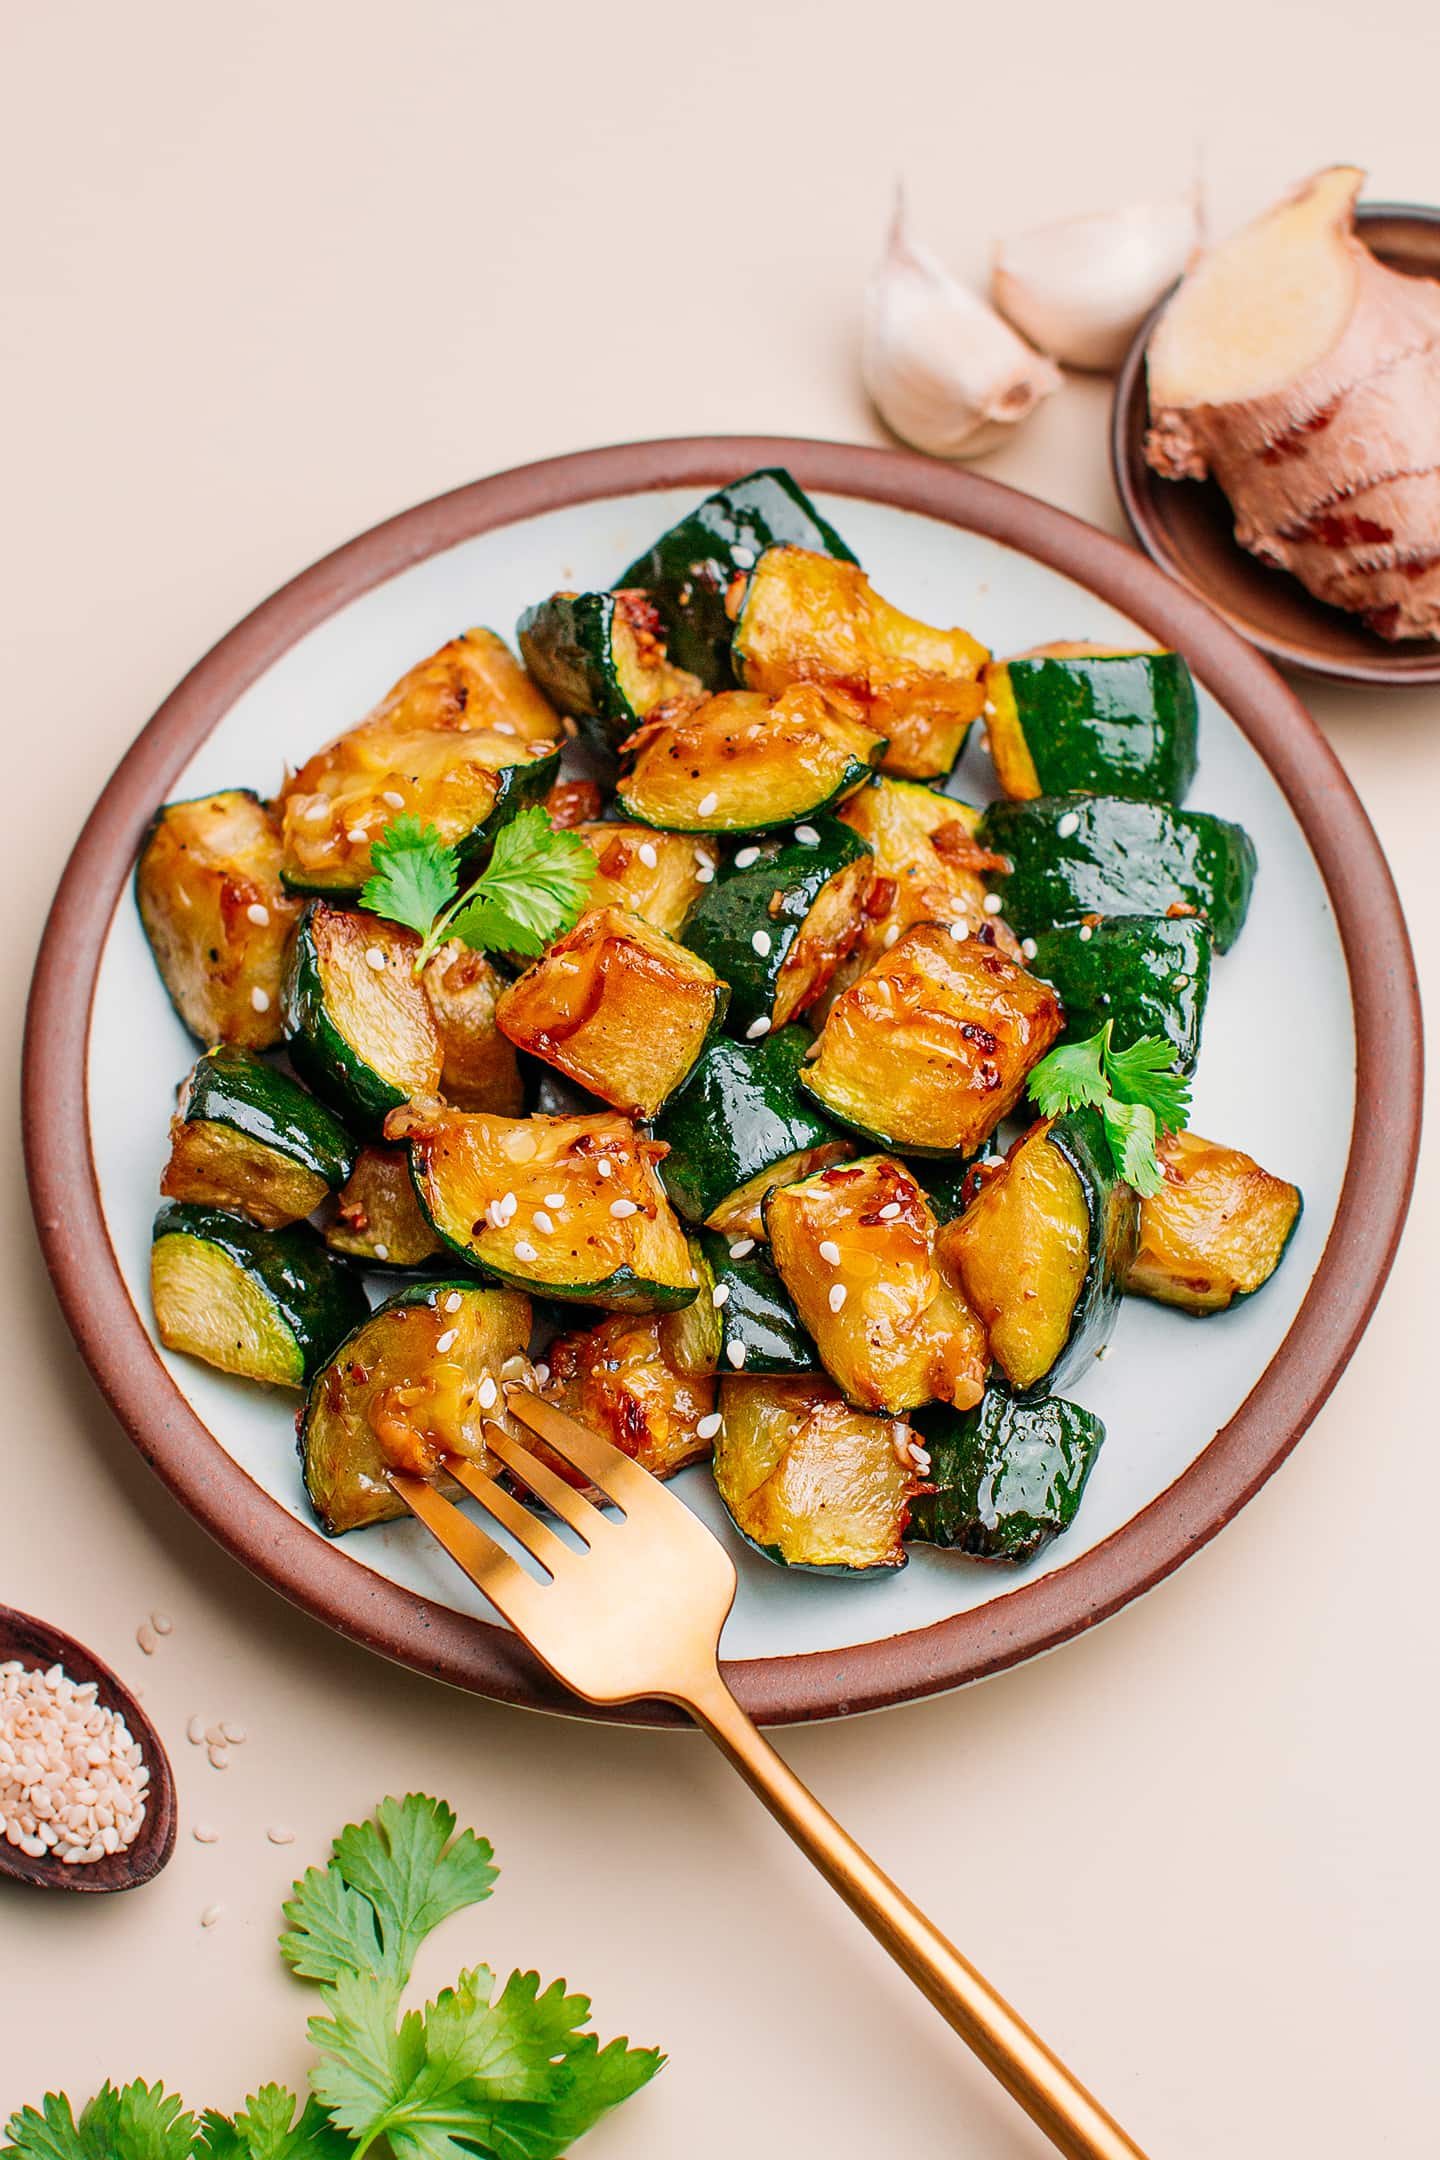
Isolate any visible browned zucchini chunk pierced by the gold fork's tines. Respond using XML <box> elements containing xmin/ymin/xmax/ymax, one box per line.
<box><xmin>298</xmin><ymin>1281</ymin><xmax>531</xmax><ymax>1538</ymax></box>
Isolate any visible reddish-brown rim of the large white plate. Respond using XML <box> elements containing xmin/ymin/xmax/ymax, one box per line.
<box><xmin>24</xmin><ymin>436</ymin><xmax>1423</xmax><ymax>1724</ymax></box>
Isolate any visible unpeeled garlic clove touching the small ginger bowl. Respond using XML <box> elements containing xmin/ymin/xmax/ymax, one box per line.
<box><xmin>991</xmin><ymin>197</ymin><xmax>1203</xmax><ymax>374</ymax></box>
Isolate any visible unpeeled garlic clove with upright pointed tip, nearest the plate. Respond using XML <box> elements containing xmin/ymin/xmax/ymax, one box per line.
<box><xmin>859</xmin><ymin>199</ymin><xmax>1060</xmax><ymax>458</ymax></box>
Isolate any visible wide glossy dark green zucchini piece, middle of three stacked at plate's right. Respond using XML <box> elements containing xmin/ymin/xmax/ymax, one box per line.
<box><xmin>980</xmin><ymin>795</ymin><xmax>1254</xmax><ymax>953</ymax></box>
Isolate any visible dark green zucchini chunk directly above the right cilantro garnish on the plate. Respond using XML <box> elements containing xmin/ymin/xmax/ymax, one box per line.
<box><xmin>1030</xmin><ymin>916</ymin><xmax>1211</xmax><ymax>1074</ymax></box>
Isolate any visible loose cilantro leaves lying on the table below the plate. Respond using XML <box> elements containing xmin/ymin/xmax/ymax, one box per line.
<box><xmin>0</xmin><ymin>1793</ymin><xmax>665</xmax><ymax>2160</ymax></box>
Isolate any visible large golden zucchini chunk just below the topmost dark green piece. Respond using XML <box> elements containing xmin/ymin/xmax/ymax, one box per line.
<box><xmin>734</xmin><ymin>546</ymin><xmax>989</xmax><ymax>780</ymax></box>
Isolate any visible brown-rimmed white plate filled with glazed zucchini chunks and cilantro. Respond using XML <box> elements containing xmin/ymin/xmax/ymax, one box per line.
<box><xmin>26</xmin><ymin>438</ymin><xmax>1421</xmax><ymax>1719</ymax></box>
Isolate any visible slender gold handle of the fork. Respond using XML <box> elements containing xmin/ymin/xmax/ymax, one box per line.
<box><xmin>676</xmin><ymin>1670</ymin><xmax>1144</xmax><ymax>2160</ymax></box>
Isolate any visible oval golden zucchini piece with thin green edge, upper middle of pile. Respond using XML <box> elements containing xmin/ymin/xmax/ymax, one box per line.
<box><xmin>615</xmin><ymin>683</ymin><xmax>885</xmax><ymax>832</ymax></box>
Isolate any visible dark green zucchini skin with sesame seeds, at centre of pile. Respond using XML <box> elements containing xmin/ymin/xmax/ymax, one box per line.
<box><xmin>684</xmin><ymin>816</ymin><xmax>872</xmax><ymax>1036</ymax></box>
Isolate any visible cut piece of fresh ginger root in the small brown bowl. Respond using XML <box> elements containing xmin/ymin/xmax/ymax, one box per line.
<box><xmin>1144</xmin><ymin>164</ymin><xmax>1440</xmax><ymax>637</ymax></box>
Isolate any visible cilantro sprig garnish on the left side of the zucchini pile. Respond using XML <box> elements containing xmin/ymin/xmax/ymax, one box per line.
<box><xmin>361</xmin><ymin>804</ymin><xmax>596</xmax><ymax>974</ymax></box>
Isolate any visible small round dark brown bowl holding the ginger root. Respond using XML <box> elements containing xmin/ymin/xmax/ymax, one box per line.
<box><xmin>1110</xmin><ymin>203</ymin><xmax>1440</xmax><ymax>689</ymax></box>
